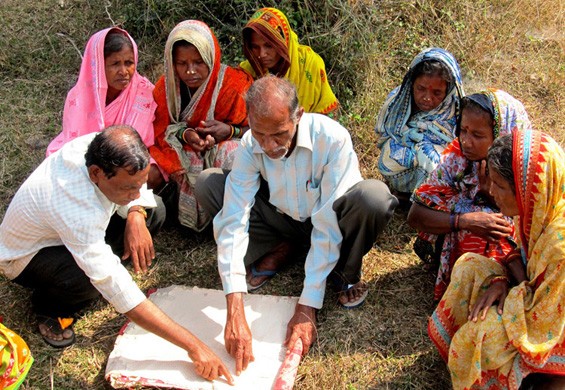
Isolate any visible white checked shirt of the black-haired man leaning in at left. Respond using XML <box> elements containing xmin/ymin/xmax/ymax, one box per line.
<box><xmin>0</xmin><ymin>133</ymin><xmax>156</xmax><ymax>313</ymax></box>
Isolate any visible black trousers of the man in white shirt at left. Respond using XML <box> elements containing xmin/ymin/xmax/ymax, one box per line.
<box><xmin>14</xmin><ymin>196</ymin><xmax>166</xmax><ymax>317</ymax></box>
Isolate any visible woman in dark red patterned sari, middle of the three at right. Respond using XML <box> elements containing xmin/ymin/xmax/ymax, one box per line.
<box><xmin>408</xmin><ymin>90</ymin><xmax>530</xmax><ymax>300</ymax></box>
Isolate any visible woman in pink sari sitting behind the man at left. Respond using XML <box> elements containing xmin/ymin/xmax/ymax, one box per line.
<box><xmin>46</xmin><ymin>27</ymin><xmax>158</xmax><ymax>180</ymax></box>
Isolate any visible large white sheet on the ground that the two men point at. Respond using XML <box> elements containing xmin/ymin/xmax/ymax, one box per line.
<box><xmin>106</xmin><ymin>286</ymin><xmax>298</xmax><ymax>390</ymax></box>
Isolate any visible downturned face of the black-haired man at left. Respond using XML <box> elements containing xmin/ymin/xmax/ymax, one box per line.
<box><xmin>88</xmin><ymin>165</ymin><xmax>150</xmax><ymax>206</ymax></box>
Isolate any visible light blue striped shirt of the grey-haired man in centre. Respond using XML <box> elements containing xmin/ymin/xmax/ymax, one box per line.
<box><xmin>214</xmin><ymin>113</ymin><xmax>362</xmax><ymax>308</ymax></box>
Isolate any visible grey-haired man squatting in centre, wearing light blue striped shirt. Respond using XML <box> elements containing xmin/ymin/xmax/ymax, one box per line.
<box><xmin>196</xmin><ymin>76</ymin><xmax>398</xmax><ymax>375</ymax></box>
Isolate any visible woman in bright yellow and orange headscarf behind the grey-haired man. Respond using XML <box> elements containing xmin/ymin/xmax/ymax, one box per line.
<box><xmin>240</xmin><ymin>8</ymin><xmax>339</xmax><ymax>114</ymax></box>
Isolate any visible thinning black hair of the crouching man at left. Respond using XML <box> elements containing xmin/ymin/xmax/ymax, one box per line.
<box><xmin>84</xmin><ymin>125</ymin><xmax>150</xmax><ymax>179</ymax></box>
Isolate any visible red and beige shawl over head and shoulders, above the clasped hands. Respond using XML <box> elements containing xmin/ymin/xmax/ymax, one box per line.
<box><xmin>149</xmin><ymin>20</ymin><xmax>253</xmax><ymax>174</ymax></box>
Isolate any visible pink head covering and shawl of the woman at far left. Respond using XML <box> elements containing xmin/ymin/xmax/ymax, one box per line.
<box><xmin>47</xmin><ymin>27</ymin><xmax>157</xmax><ymax>156</ymax></box>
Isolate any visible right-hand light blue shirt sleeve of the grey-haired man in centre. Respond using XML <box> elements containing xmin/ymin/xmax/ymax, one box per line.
<box><xmin>299</xmin><ymin>133</ymin><xmax>360</xmax><ymax>309</ymax></box>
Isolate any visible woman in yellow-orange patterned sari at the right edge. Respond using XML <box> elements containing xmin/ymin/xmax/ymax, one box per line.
<box><xmin>428</xmin><ymin>131</ymin><xmax>565</xmax><ymax>389</ymax></box>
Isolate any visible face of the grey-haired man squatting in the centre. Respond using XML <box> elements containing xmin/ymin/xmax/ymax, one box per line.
<box><xmin>249</xmin><ymin>106</ymin><xmax>304</xmax><ymax>160</ymax></box>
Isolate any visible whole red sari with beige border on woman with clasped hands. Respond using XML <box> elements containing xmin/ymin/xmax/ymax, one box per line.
<box><xmin>149</xmin><ymin>20</ymin><xmax>253</xmax><ymax>231</ymax></box>
